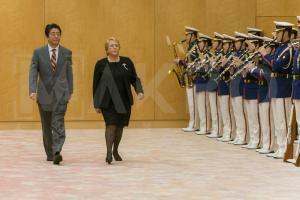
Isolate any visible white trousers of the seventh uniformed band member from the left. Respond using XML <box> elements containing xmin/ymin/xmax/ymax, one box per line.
<box><xmin>258</xmin><ymin>102</ymin><xmax>273</xmax><ymax>150</ymax></box>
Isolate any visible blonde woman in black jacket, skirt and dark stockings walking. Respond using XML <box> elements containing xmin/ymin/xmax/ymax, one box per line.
<box><xmin>93</xmin><ymin>37</ymin><xmax>144</xmax><ymax>164</ymax></box>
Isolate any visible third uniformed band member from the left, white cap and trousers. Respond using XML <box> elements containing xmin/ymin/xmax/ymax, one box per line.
<box><xmin>206</xmin><ymin>32</ymin><xmax>223</xmax><ymax>138</ymax></box>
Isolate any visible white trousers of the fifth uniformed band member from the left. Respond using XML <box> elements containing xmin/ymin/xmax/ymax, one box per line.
<box><xmin>231</xmin><ymin>96</ymin><xmax>247</xmax><ymax>141</ymax></box>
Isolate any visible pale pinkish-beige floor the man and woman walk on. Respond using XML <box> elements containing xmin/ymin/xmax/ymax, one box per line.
<box><xmin>0</xmin><ymin>129</ymin><xmax>300</xmax><ymax>200</ymax></box>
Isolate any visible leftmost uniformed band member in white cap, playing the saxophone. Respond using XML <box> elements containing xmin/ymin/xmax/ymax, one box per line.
<box><xmin>182</xmin><ymin>26</ymin><xmax>199</xmax><ymax>132</ymax></box>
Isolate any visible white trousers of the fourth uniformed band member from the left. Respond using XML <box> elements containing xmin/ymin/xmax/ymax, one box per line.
<box><xmin>218</xmin><ymin>95</ymin><xmax>235</xmax><ymax>139</ymax></box>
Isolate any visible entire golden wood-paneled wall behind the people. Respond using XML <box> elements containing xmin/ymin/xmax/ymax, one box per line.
<box><xmin>0</xmin><ymin>0</ymin><xmax>300</xmax><ymax>128</ymax></box>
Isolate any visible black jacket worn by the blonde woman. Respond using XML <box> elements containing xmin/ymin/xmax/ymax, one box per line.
<box><xmin>93</xmin><ymin>56</ymin><xmax>143</xmax><ymax>113</ymax></box>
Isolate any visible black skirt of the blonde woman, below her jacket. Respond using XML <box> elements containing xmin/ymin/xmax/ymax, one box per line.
<box><xmin>101</xmin><ymin>105</ymin><xmax>131</xmax><ymax>127</ymax></box>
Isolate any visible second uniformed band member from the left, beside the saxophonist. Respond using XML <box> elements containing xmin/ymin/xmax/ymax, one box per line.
<box><xmin>194</xmin><ymin>33</ymin><xmax>211</xmax><ymax>135</ymax></box>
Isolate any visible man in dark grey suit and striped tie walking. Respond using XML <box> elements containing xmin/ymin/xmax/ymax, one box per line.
<box><xmin>29</xmin><ymin>24</ymin><xmax>73</xmax><ymax>165</ymax></box>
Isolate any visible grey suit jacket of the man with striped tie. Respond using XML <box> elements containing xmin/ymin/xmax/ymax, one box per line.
<box><xmin>29</xmin><ymin>45</ymin><xmax>73</xmax><ymax>105</ymax></box>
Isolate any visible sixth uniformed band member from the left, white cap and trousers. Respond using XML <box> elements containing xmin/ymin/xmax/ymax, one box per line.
<box><xmin>242</xmin><ymin>33</ymin><xmax>262</xmax><ymax>149</ymax></box>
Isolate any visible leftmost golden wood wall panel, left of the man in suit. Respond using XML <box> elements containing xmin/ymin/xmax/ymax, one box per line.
<box><xmin>0</xmin><ymin>0</ymin><xmax>45</xmax><ymax>121</ymax></box>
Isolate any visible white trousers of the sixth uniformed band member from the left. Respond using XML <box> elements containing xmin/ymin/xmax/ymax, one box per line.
<box><xmin>244</xmin><ymin>99</ymin><xmax>259</xmax><ymax>144</ymax></box>
